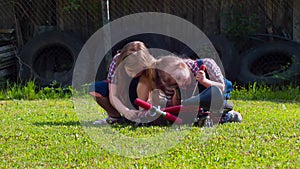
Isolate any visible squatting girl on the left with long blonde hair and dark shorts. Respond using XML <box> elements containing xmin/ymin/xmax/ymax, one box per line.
<box><xmin>89</xmin><ymin>41</ymin><xmax>154</xmax><ymax>124</ymax></box>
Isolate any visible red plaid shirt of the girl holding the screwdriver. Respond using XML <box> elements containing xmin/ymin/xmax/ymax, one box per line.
<box><xmin>184</xmin><ymin>58</ymin><xmax>225</xmax><ymax>84</ymax></box>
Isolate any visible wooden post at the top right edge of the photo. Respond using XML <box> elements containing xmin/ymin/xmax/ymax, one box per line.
<box><xmin>293</xmin><ymin>0</ymin><xmax>300</xmax><ymax>42</ymax></box>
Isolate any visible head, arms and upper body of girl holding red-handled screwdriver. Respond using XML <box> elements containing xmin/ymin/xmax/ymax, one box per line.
<box><xmin>156</xmin><ymin>55</ymin><xmax>225</xmax><ymax>106</ymax></box>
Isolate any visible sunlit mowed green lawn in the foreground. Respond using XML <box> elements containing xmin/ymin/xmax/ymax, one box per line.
<box><xmin>0</xmin><ymin>96</ymin><xmax>300</xmax><ymax>168</ymax></box>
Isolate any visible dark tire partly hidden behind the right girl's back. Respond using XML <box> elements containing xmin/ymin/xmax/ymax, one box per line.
<box><xmin>208</xmin><ymin>35</ymin><xmax>240</xmax><ymax>81</ymax></box>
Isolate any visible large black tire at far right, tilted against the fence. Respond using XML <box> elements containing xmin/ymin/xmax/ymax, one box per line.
<box><xmin>238</xmin><ymin>41</ymin><xmax>300</xmax><ymax>85</ymax></box>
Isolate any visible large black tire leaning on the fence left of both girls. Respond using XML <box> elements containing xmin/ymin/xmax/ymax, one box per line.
<box><xmin>20</xmin><ymin>32</ymin><xmax>83</xmax><ymax>87</ymax></box>
